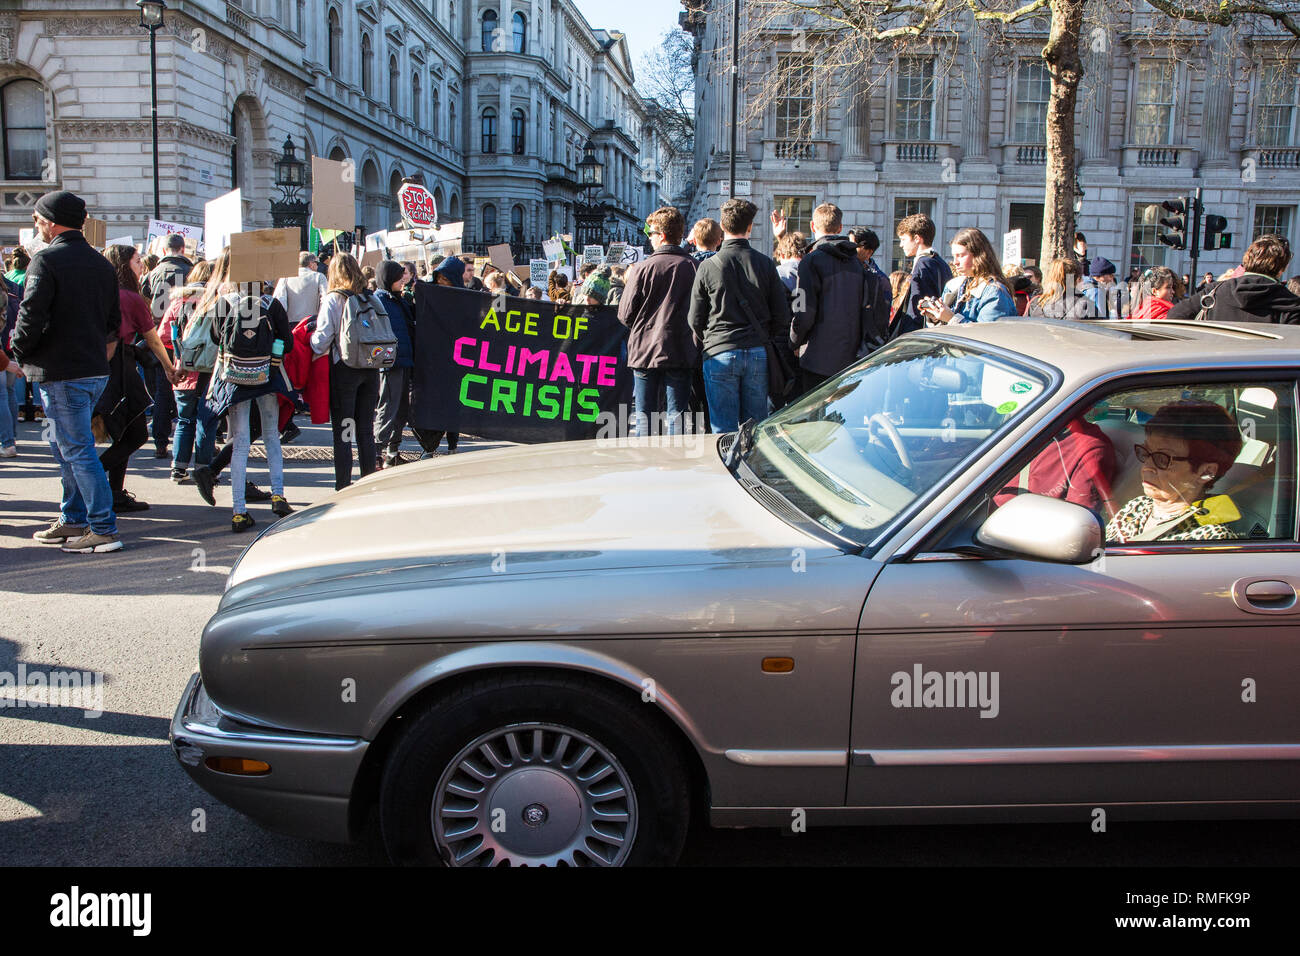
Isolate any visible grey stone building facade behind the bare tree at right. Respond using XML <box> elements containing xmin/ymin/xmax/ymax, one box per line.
<box><xmin>681</xmin><ymin>0</ymin><xmax>1300</xmax><ymax>280</ymax></box>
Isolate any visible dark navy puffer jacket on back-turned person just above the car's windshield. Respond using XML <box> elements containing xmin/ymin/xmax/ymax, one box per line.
<box><xmin>790</xmin><ymin>235</ymin><xmax>867</xmax><ymax>375</ymax></box>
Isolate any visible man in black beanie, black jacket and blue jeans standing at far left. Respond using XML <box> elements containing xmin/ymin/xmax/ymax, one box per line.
<box><xmin>13</xmin><ymin>191</ymin><xmax>122</xmax><ymax>554</ymax></box>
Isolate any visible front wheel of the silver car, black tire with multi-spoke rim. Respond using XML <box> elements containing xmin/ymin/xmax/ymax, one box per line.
<box><xmin>380</xmin><ymin>675</ymin><xmax>690</xmax><ymax>866</ymax></box>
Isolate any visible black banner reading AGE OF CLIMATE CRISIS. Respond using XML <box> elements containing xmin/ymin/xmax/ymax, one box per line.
<box><xmin>411</xmin><ymin>282</ymin><xmax>632</xmax><ymax>442</ymax></box>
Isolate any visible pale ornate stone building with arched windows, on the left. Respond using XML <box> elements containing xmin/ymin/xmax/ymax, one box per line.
<box><xmin>0</xmin><ymin>0</ymin><xmax>662</xmax><ymax>251</ymax></box>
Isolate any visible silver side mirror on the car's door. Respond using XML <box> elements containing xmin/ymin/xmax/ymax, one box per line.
<box><xmin>975</xmin><ymin>494</ymin><xmax>1102</xmax><ymax>564</ymax></box>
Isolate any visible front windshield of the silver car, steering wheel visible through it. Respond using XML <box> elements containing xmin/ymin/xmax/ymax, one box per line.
<box><xmin>744</xmin><ymin>337</ymin><xmax>1047</xmax><ymax>545</ymax></box>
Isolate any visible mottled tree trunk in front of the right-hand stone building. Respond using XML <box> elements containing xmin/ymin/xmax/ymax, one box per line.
<box><xmin>1040</xmin><ymin>0</ymin><xmax>1087</xmax><ymax>271</ymax></box>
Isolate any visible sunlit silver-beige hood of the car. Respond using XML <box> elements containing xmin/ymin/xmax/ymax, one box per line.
<box><xmin>222</xmin><ymin>436</ymin><xmax>833</xmax><ymax>607</ymax></box>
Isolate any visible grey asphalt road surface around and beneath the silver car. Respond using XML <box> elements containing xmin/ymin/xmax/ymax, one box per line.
<box><xmin>0</xmin><ymin>423</ymin><xmax>1300</xmax><ymax>866</ymax></box>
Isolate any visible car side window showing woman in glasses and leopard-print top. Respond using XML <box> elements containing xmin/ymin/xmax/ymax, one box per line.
<box><xmin>944</xmin><ymin>381</ymin><xmax>1296</xmax><ymax>549</ymax></box>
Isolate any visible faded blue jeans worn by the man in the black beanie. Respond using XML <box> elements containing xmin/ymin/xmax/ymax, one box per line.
<box><xmin>39</xmin><ymin>375</ymin><xmax>117</xmax><ymax>535</ymax></box>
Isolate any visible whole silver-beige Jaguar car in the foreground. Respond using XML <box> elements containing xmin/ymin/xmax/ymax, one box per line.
<box><xmin>172</xmin><ymin>320</ymin><xmax>1300</xmax><ymax>866</ymax></box>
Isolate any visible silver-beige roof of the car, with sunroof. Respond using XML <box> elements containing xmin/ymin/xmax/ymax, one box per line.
<box><xmin>922</xmin><ymin>316</ymin><xmax>1300</xmax><ymax>380</ymax></box>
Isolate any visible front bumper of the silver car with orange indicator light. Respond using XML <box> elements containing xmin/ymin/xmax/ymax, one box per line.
<box><xmin>169</xmin><ymin>674</ymin><xmax>369</xmax><ymax>843</ymax></box>
